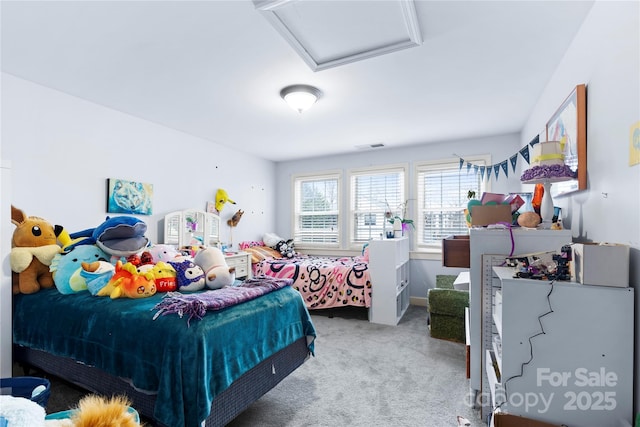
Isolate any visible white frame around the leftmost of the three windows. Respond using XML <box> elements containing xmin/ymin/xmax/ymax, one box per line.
<box><xmin>291</xmin><ymin>170</ymin><xmax>343</xmax><ymax>249</ymax></box>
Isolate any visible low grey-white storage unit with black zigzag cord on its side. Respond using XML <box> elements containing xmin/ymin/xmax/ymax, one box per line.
<box><xmin>485</xmin><ymin>267</ymin><xmax>634</xmax><ymax>427</ymax></box>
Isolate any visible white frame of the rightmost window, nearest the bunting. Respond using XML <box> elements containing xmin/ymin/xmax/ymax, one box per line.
<box><xmin>413</xmin><ymin>154</ymin><xmax>491</xmax><ymax>254</ymax></box>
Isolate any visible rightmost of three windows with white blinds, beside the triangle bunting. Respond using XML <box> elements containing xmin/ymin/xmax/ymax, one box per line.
<box><xmin>415</xmin><ymin>157</ymin><xmax>488</xmax><ymax>250</ymax></box>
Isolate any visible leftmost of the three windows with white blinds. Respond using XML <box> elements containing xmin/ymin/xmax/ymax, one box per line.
<box><xmin>293</xmin><ymin>172</ymin><xmax>340</xmax><ymax>247</ymax></box>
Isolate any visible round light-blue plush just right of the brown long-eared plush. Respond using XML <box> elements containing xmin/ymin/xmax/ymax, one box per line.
<box><xmin>49</xmin><ymin>245</ymin><xmax>113</xmax><ymax>295</ymax></box>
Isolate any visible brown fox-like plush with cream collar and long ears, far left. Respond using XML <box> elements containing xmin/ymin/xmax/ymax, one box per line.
<box><xmin>9</xmin><ymin>205</ymin><xmax>62</xmax><ymax>294</ymax></box>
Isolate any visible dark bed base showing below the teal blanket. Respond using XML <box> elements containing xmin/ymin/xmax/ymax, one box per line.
<box><xmin>14</xmin><ymin>338</ymin><xmax>310</xmax><ymax>427</ymax></box>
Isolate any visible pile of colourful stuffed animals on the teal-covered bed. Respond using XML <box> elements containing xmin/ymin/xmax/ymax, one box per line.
<box><xmin>10</xmin><ymin>207</ymin><xmax>241</xmax><ymax>299</ymax></box>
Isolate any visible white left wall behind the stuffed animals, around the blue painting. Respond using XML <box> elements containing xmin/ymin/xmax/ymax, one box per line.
<box><xmin>0</xmin><ymin>73</ymin><xmax>276</xmax><ymax>244</ymax></box>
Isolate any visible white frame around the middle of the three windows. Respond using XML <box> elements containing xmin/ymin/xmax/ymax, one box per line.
<box><xmin>345</xmin><ymin>163</ymin><xmax>411</xmax><ymax>250</ymax></box>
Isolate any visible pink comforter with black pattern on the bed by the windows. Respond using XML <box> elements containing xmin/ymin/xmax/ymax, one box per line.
<box><xmin>252</xmin><ymin>254</ymin><xmax>371</xmax><ymax>309</ymax></box>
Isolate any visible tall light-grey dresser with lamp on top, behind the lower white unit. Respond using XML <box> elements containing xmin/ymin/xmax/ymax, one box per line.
<box><xmin>468</xmin><ymin>228</ymin><xmax>571</xmax><ymax>419</ymax></box>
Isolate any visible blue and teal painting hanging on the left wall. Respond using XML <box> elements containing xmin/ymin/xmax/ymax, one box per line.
<box><xmin>107</xmin><ymin>178</ymin><xmax>153</xmax><ymax>215</ymax></box>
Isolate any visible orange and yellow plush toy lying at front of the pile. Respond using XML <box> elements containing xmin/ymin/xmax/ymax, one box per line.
<box><xmin>96</xmin><ymin>261</ymin><xmax>156</xmax><ymax>299</ymax></box>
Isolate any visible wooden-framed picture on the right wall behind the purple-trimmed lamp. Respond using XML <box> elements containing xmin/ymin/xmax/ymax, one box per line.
<box><xmin>546</xmin><ymin>84</ymin><xmax>587</xmax><ymax>196</ymax></box>
